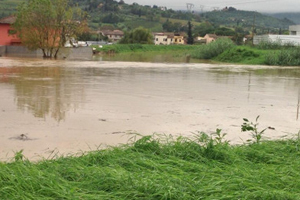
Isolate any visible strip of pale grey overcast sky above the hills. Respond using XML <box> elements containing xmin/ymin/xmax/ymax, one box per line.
<box><xmin>124</xmin><ymin>0</ymin><xmax>300</xmax><ymax>12</ymax></box>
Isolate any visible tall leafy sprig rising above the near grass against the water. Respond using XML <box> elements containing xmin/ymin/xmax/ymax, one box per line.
<box><xmin>241</xmin><ymin>115</ymin><xmax>267</xmax><ymax>144</ymax></box>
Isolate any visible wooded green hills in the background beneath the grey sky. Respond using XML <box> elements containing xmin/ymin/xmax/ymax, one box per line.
<box><xmin>0</xmin><ymin>0</ymin><xmax>295</xmax><ymax>35</ymax></box>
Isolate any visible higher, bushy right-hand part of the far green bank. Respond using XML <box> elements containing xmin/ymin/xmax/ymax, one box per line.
<box><xmin>191</xmin><ymin>39</ymin><xmax>300</xmax><ymax>66</ymax></box>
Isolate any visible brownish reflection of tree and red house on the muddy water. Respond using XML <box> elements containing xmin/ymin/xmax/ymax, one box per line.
<box><xmin>0</xmin><ymin>66</ymin><xmax>84</xmax><ymax>121</ymax></box>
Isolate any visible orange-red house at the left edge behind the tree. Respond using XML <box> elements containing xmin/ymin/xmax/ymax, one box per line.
<box><xmin>0</xmin><ymin>16</ymin><xmax>21</xmax><ymax>46</ymax></box>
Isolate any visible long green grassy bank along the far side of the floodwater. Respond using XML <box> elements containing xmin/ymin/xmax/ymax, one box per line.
<box><xmin>94</xmin><ymin>39</ymin><xmax>300</xmax><ymax>66</ymax></box>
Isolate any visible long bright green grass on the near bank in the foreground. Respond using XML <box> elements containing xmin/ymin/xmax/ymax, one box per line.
<box><xmin>0</xmin><ymin>133</ymin><xmax>300</xmax><ymax>200</ymax></box>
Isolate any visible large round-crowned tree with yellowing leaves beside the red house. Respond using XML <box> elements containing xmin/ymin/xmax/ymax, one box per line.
<box><xmin>13</xmin><ymin>0</ymin><xmax>86</xmax><ymax>58</ymax></box>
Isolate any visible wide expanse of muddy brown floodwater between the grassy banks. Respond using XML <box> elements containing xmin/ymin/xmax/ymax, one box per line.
<box><xmin>0</xmin><ymin>58</ymin><xmax>300</xmax><ymax>160</ymax></box>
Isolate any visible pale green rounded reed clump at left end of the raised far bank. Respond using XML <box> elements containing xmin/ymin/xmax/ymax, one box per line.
<box><xmin>191</xmin><ymin>38</ymin><xmax>234</xmax><ymax>59</ymax></box>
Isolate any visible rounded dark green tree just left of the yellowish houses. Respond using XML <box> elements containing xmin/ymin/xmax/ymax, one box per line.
<box><xmin>119</xmin><ymin>27</ymin><xmax>153</xmax><ymax>44</ymax></box>
